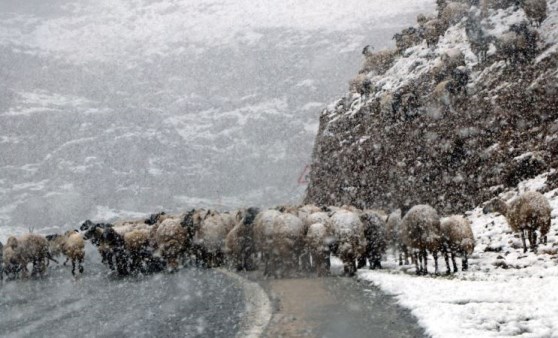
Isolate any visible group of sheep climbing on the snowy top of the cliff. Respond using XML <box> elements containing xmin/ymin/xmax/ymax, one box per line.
<box><xmin>349</xmin><ymin>0</ymin><xmax>548</xmax><ymax>119</ymax></box>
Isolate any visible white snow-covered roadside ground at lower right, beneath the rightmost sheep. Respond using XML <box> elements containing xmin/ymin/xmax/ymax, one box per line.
<box><xmin>358</xmin><ymin>174</ymin><xmax>558</xmax><ymax>337</ymax></box>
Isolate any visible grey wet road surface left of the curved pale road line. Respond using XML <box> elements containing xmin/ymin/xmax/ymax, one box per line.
<box><xmin>0</xmin><ymin>263</ymin><xmax>244</xmax><ymax>337</ymax></box>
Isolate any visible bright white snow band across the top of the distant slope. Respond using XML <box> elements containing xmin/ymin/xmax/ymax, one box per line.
<box><xmin>0</xmin><ymin>0</ymin><xmax>433</xmax><ymax>67</ymax></box>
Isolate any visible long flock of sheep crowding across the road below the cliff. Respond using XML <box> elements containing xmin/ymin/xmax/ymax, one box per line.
<box><xmin>0</xmin><ymin>192</ymin><xmax>551</xmax><ymax>279</ymax></box>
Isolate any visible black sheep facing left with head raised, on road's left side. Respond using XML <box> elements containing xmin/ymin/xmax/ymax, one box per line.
<box><xmin>80</xmin><ymin>220</ymin><xmax>129</xmax><ymax>276</ymax></box>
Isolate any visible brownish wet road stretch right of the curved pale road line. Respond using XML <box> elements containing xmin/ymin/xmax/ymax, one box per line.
<box><xmin>252</xmin><ymin>277</ymin><xmax>425</xmax><ymax>338</ymax></box>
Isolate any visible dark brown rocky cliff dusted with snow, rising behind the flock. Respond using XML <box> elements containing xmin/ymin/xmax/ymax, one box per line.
<box><xmin>305</xmin><ymin>0</ymin><xmax>558</xmax><ymax>213</ymax></box>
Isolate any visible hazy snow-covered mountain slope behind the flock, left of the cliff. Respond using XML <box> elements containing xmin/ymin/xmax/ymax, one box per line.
<box><xmin>0</xmin><ymin>0</ymin><xmax>434</xmax><ymax>232</ymax></box>
